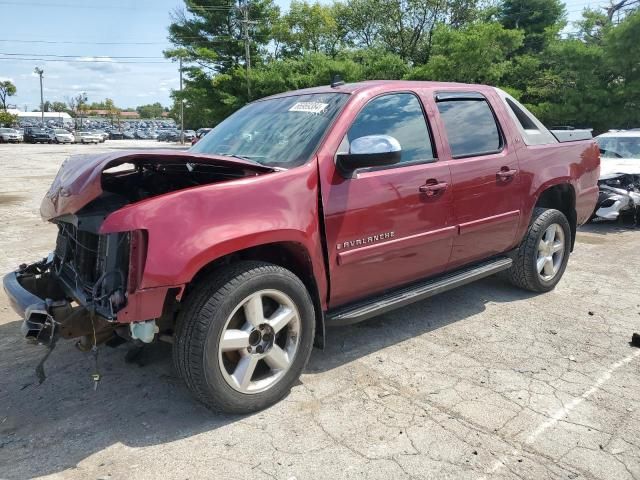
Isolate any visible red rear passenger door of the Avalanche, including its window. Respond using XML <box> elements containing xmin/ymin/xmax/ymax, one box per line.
<box><xmin>435</xmin><ymin>91</ymin><xmax>522</xmax><ymax>268</ymax></box>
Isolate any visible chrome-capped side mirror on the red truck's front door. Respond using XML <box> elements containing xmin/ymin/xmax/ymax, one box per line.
<box><xmin>336</xmin><ymin>135</ymin><xmax>402</xmax><ymax>174</ymax></box>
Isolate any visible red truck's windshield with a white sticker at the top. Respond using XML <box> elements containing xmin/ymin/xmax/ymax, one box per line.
<box><xmin>191</xmin><ymin>93</ymin><xmax>349</xmax><ymax>168</ymax></box>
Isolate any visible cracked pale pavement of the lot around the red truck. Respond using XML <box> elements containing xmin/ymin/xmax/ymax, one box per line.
<box><xmin>0</xmin><ymin>141</ymin><xmax>640</xmax><ymax>480</ymax></box>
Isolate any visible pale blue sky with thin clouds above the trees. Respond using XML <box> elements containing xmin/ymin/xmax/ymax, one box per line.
<box><xmin>0</xmin><ymin>0</ymin><xmax>604</xmax><ymax>110</ymax></box>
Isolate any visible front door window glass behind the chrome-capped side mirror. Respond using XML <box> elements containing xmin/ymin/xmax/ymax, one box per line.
<box><xmin>340</xmin><ymin>93</ymin><xmax>434</xmax><ymax>163</ymax></box>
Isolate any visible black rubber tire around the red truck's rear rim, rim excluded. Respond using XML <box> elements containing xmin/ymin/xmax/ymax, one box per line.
<box><xmin>505</xmin><ymin>208</ymin><xmax>571</xmax><ymax>292</ymax></box>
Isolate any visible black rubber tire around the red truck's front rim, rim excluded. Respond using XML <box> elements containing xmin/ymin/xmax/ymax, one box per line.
<box><xmin>173</xmin><ymin>261</ymin><xmax>315</xmax><ymax>413</ymax></box>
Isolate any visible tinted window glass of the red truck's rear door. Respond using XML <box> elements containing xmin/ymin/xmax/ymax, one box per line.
<box><xmin>438</xmin><ymin>98</ymin><xmax>502</xmax><ymax>158</ymax></box>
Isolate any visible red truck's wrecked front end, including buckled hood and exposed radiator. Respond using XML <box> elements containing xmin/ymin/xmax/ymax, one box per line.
<box><xmin>3</xmin><ymin>151</ymin><xmax>273</xmax><ymax>350</ymax></box>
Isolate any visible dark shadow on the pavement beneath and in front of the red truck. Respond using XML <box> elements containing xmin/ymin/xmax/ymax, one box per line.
<box><xmin>0</xmin><ymin>278</ymin><xmax>533</xmax><ymax>479</ymax></box>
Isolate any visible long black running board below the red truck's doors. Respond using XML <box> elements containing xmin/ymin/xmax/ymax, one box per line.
<box><xmin>326</xmin><ymin>257</ymin><xmax>513</xmax><ymax>326</ymax></box>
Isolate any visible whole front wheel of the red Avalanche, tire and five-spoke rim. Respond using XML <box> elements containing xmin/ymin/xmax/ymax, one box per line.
<box><xmin>173</xmin><ymin>261</ymin><xmax>315</xmax><ymax>413</ymax></box>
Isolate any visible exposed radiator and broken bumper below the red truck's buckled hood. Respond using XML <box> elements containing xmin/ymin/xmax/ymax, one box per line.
<box><xmin>4</xmin><ymin>212</ymin><xmax>146</xmax><ymax>350</ymax></box>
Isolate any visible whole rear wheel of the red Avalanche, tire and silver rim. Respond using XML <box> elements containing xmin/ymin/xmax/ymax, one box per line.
<box><xmin>506</xmin><ymin>208</ymin><xmax>571</xmax><ymax>292</ymax></box>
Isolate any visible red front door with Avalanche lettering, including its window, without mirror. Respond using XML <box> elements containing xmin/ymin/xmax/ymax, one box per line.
<box><xmin>320</xmin><ymin>92</ymin><xmax>456</xmax><ymax>307</ymax></box>
